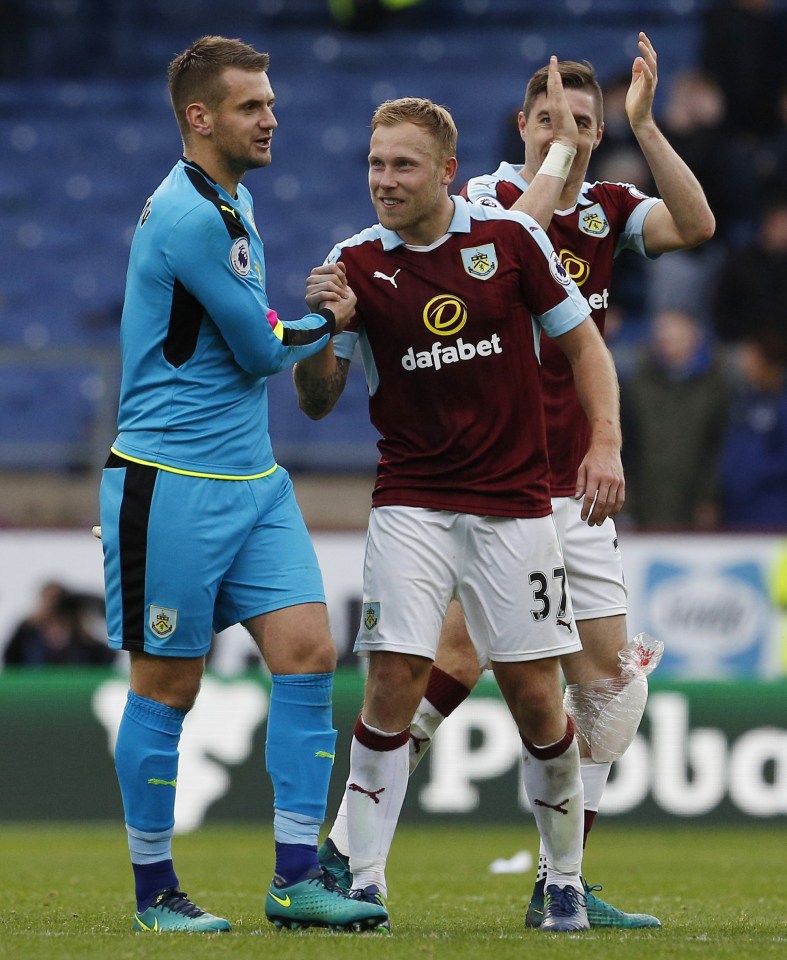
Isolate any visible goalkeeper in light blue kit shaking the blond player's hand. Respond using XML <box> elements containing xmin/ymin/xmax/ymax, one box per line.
<box><xmin>100</xmin><ymin>37</ymin><xmax>387</xmax><ymax>932</ymax></box>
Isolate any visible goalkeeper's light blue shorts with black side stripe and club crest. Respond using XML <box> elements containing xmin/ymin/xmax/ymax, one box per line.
<box><xmin>100</xmin><ymin>455</ymin><xmax>325</xmax><ymax>657</ymax></box>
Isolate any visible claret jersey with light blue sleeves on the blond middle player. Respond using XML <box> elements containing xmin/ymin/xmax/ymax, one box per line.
<box><xmin>328</xmin><ymin>190</ymin><xmax>590</xmax><ymax>517</ymax></box>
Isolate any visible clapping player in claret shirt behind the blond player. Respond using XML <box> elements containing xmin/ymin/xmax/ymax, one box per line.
<box><xmin>320</xmin><ymin>34</ymin><xmax>714</xmax><ymax>928</ymax></box>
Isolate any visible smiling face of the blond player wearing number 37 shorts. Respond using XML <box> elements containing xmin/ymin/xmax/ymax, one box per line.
<box><xmin>369</xmin><ymin>122</ymin><xmax>456</xmax><ymax>246</ymax></box>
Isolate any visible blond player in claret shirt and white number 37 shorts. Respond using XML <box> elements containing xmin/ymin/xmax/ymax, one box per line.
<box><xmin>295</xmin><ymin>98</ymin><xmax>624</xmax><ymax>931</ymax></box>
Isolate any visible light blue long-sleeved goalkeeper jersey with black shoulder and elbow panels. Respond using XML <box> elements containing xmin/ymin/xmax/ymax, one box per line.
<box><xmin>113</xmin><ymin>159</ymin><xmax>334</xmax><ymax>479</ymax></box>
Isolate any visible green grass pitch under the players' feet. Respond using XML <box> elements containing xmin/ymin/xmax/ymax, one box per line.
<box><xmin>0</xmin><ymin>818</ymin><xmax>787</xmax><ymax>960</ymax></box>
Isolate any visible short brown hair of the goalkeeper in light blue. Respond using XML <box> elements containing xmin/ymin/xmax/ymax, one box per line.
<box><xmin>167</xmin><ymin>37</ymin><xmax>270</xmax><ymax>139</ymax></box>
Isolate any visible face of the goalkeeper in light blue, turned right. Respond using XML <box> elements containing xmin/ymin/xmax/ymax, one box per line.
<box><xmin>211</xmin><ymin>67</ymin><xmax>278</xmax><ymax>176</ymax></box>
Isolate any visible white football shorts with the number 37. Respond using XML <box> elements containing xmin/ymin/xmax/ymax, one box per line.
<box><xmin>355</xmin><ymin>506</ymin><xmax>582</xmax><ymax>663</ymax></box>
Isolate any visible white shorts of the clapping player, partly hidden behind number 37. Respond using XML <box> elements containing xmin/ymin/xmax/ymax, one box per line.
<box><xmin>552</xmin><ymin>497</ymin><xmax>628</xmax><ymax>620</ymax></box>
